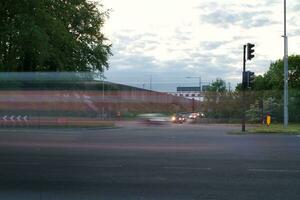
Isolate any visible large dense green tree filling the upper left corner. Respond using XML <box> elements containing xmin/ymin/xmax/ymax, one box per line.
<box><xmin>0</xmin><ymin>0</ymin><xmax>111</xmax><ymax>72</ymax></box>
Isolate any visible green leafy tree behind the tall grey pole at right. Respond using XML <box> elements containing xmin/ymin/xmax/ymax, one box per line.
<box><xmin>236</xmin><ymin>55</ymin><xmax>300</xmax><ymax>122</ymax></box>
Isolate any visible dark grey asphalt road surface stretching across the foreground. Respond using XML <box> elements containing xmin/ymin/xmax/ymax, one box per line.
<box><xmin>0</xmin><ymin>123</ymin><xmax>300</xmax><ymax>200</ymax></box>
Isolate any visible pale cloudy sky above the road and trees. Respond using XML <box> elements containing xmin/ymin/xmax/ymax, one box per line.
<box><xmin>98</xmin><ymin>0</ymin><xmax>300</xmax><ymax>91</ymax></box>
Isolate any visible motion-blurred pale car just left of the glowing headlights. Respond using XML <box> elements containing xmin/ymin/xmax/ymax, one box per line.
<box><xmin>138</xmin><ymin>113</ymin><xmax>170</xmax><ymax>125</ymax></box>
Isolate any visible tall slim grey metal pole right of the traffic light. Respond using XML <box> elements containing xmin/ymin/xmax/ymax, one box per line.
<box><xmin>283</xmin><ymin>0</ymin><xmax>289</xmax><ymax>128</ymax></box>
